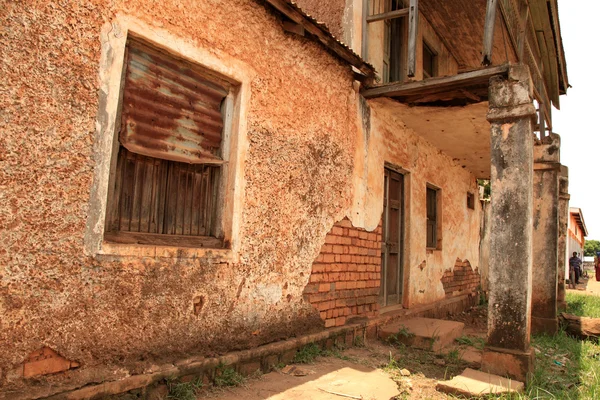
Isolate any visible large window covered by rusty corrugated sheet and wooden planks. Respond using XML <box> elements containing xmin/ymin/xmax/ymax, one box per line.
<box><xmin>104</xmin><ymin>40</ymin><xmax>230</xmax><ymax>247</ymax></box>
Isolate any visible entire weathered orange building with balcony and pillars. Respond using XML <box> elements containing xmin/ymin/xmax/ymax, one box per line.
<box><xmin>0</xmin><ymin>0</ymin><xmax>568</xmax><ymax>399</ymax></box>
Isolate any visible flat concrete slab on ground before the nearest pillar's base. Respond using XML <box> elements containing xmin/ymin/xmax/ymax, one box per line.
<box><xmin>435</xmin><ymin>368</ymin><xmax>525</xmax><ymax>398</ymax></box>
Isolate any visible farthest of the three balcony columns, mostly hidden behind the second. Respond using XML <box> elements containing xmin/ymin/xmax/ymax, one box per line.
<box><xmin>557</xmin><ymin>165</ymin><xmax>571</xmax><ymax>311</ymax></box>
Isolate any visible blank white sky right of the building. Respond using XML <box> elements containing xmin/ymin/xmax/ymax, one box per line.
<box><xmin>552</xmin><ymin>0</ymin><xmax>600</xmax><ymax>240</ymax></box>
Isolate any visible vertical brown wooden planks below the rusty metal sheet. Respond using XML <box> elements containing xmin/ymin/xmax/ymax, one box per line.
<box><xmin>108</xmin><ymin>147</ymin><xmax>220</xmax><ymax>236</ymax></box>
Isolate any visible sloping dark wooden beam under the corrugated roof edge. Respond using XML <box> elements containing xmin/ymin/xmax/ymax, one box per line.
<box><xmin>266</xmin><ymin>0</ymin><xmax>375</xmax><ymax>77</ymax></box>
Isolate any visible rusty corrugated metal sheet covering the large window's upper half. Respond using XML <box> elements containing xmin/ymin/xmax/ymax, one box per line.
<box><xmin>120</xmin><ymin>41</ymin><xmax>228</xmax><ymax>164</ymax></box>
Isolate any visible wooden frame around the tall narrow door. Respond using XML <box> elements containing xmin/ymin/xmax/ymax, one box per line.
<box><xmin>380</xmin><ymin>161</ymin><xmax>411</xmax><ymax>311</ymax></box>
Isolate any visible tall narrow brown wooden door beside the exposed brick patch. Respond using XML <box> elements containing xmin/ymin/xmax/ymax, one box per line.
<box><xmin>379</xmin><ymin>168</ymin><xmax>404</xmax><ymax>307</ymax></box>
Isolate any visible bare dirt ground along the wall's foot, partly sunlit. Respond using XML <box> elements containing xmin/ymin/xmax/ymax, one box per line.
<box><xmin>202</xmin><ymin>307</ymin><xmax>487</xmax><ymax>400</ymax></box>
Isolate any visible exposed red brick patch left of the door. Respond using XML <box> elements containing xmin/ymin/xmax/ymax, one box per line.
<box><xmin>304</xmin><ymin>219</ymin><xmax>381</xmax><ymax>328</ymax></box>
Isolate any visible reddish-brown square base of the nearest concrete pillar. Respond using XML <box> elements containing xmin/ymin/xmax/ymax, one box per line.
<box><xmin>481</xmin><ymin>347</ymin><xmax>535</xmax><ymax>382</ymax></box>
